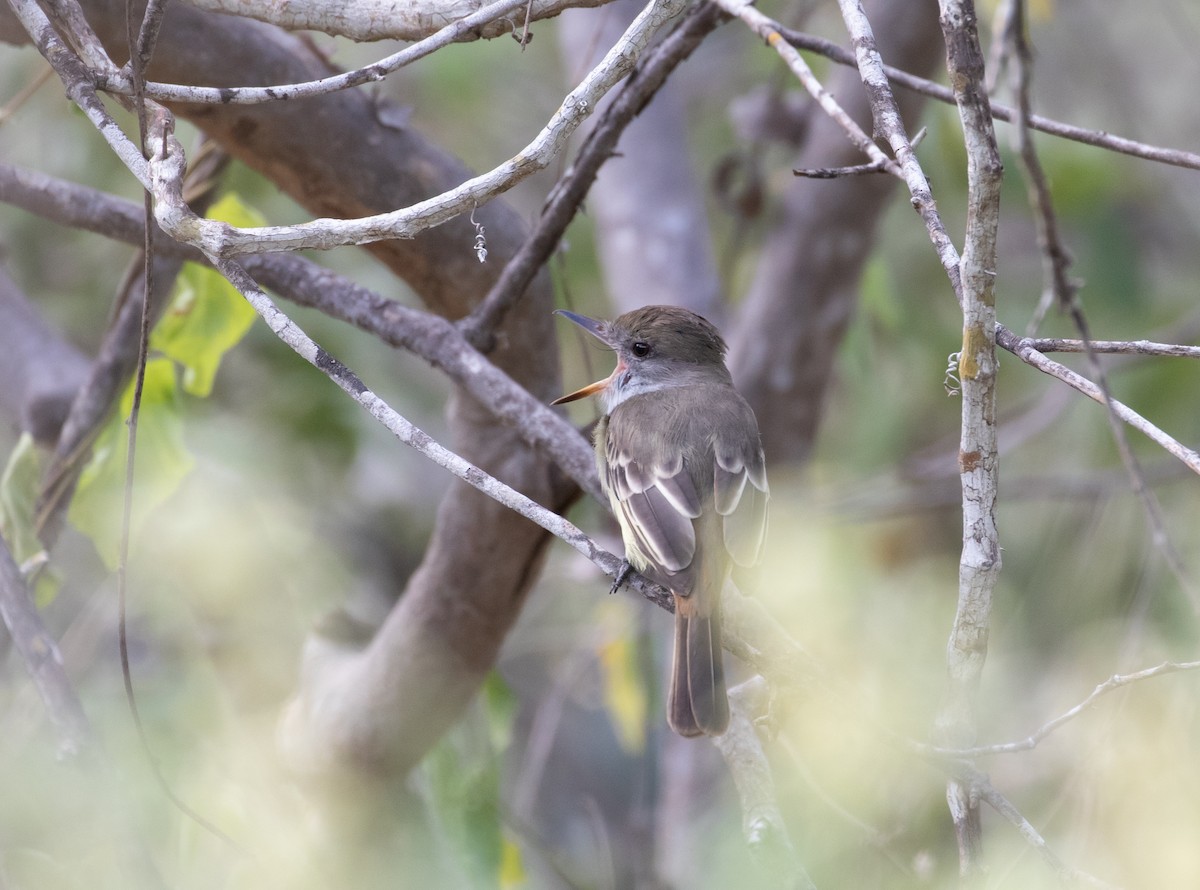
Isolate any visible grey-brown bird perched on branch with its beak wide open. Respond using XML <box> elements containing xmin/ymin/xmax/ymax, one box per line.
<box><xmin>553</xmin><ymin>306</ymin><xmax>769</xmax><ymax>736</ymax></box>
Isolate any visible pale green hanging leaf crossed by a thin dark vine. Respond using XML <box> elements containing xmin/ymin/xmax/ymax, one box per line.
<box><xmin>70</xmin><ymin>359</ymin><xmax>196</xmax><ymax>569</ymax></box>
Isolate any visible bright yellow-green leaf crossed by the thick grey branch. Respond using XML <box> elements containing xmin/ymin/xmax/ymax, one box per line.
<box><xmin>150</xmin><ymin>194</ymin><xmax>263</xmax><ymax>398</ymax></box>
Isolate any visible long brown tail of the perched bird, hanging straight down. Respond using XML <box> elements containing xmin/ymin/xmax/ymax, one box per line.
<box><xmin>667</xmin><ymin>599</ymin><xmax>730</xmax><ymax>736</ymax></box>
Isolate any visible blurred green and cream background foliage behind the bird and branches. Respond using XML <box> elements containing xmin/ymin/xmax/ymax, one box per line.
<box><xmin>0</xmin><ymin>0</ymin><xmax>1200</xmax><ymax>888</ymax></box>
